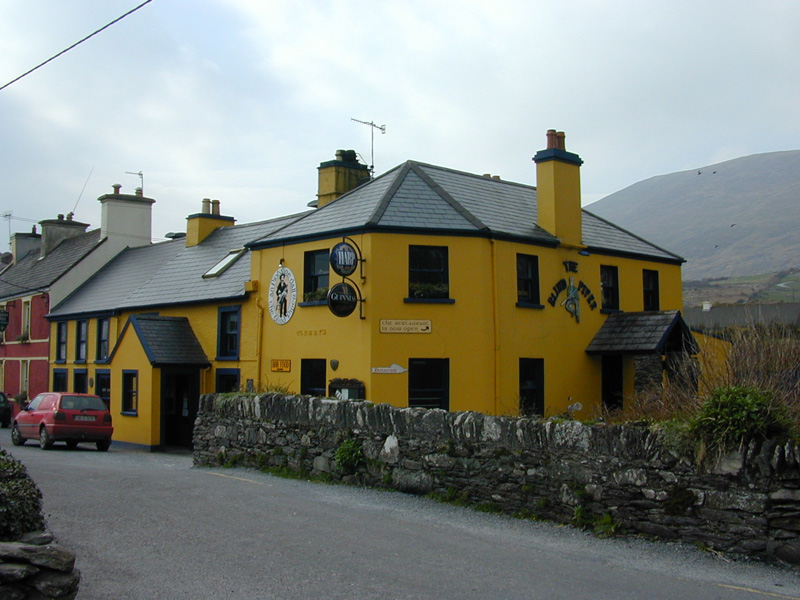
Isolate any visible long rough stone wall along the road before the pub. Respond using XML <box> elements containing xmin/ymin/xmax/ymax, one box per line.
<box><xmin>194</xmin><ymin>394</ymin><xmax>800</xmax><ymax>564</ymax></box>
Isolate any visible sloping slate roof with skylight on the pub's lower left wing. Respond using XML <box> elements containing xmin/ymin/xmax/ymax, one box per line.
<box><xmin>50</xmin><ymin>215</ymin><xmax>306</xmax><ymax>318</ymax></box>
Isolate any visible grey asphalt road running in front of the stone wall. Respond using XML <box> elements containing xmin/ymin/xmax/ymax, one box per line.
<box><xmin>0</xmin><ymin>429</ymin><xmax>800</xmax><ymax>600</ymax></box>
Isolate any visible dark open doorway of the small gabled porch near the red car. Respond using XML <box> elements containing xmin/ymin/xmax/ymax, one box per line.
<box><xmin>161</xmin><ymin>368</ymin><xmax>200</xmax><ymax>448</ymax></box>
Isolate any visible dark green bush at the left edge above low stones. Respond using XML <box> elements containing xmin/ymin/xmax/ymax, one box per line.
<box><xmin>0</xmin><ymin>448</ymin><xmax>44</xmax><ymax>541</ymax></box>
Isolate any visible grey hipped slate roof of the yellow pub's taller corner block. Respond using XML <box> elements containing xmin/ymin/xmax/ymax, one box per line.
<box><xmin>250</xmin><ymin>161</ymin><xmax>683</xmax><ymax>262</ymax></box>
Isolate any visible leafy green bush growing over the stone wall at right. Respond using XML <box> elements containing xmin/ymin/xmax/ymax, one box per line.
<box><xmin>690</xmin><ymin>386</ymin><xmax>792</xmax><ymax>452</ymax></box>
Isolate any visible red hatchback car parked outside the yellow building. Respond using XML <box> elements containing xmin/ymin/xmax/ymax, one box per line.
<box><xmin>11</xmin><ymin>392</ymin><xmax>114</xmax><ymax>451</ymax></box>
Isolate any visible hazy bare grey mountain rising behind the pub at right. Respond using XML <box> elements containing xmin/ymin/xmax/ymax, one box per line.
<box><xmin>585</xmin><ymin>150</ymin><xmax>800</xmax><ymax>281</ymax></box>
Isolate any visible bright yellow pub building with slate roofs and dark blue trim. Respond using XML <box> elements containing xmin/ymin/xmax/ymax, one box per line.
<box><xmin>49</xmin><ymin>131</ymin><xmax>696</xmax><ymax>447</ymax></box>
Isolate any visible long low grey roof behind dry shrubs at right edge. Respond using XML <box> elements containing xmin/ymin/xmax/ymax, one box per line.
<box><xmin>683</xmin><ymin>302</ymin><xmax>800</xmax><ymax>330</ymax></box>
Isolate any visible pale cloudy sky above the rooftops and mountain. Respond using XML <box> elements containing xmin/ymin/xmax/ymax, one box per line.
<box><xmin>0</xmin><ymin>0</ymin><xmax>800</xmax><ymax>244</ymax></box>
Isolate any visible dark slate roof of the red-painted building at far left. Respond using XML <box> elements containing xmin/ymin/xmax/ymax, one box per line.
<box><xmin>0</xmin><ymin>229</ymin><xmax>100</xmax><ymax>300</ymax></box>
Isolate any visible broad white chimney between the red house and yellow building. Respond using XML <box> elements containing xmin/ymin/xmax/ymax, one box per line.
<box><xmin>97</xmin><ymin>183</ymin><xmax>155</xmax><ymax>247</ymax></box>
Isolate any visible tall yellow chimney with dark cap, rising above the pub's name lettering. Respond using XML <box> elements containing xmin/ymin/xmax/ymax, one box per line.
<box><xmin>533</xmin><ymin>129</ymin><xmax>584</xmax><ymax>248</ymax></box>
